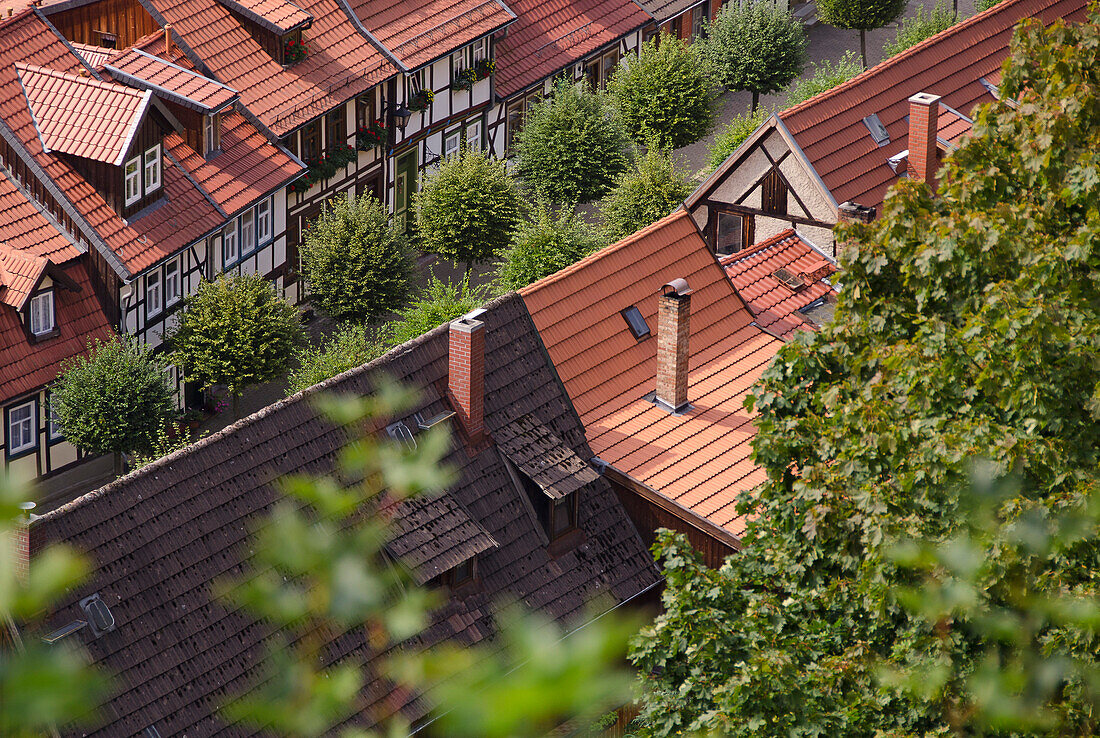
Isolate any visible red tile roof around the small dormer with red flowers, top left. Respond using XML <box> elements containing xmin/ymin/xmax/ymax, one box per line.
<box><xmin>141</xmin><ymin>0</ymin><xmax>396</xmax><ymax>135</ymax></box>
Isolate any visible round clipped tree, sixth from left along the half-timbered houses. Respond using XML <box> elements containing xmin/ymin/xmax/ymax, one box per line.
<box><xmin>608</xmin><ymin>34</ymin><xmax>716</xmax><ymax>148</ymax></box>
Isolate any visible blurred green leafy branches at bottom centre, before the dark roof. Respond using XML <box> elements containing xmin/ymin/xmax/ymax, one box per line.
<box><xmin>216</xmin><ymin>382</ymin><xmax>637</xmax><ymax>738</ymax></box>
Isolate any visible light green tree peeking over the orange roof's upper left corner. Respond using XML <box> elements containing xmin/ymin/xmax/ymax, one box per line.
<box><xmin>496</xmin><ymin>202</ymin><xmax>606</xmax><ymax>291</ymax></box>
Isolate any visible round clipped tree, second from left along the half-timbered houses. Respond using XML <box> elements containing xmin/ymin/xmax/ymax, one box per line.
<box><xmin>165</xmin><ymin>274</ymin><xmax>305</xmax><ymax>419</ymax></box>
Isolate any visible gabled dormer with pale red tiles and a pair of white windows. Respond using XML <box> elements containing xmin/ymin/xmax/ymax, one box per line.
<box><xmin>15</xmin><ymin>64</ymin><xmax>178</xmax><ymax>219</ymax></box>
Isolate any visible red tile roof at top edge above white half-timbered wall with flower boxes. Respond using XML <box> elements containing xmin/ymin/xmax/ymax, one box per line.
<box><xmin>349</xmin><ymin>0</ymin><xmax>513</xmax><ymax>69</ymax></box>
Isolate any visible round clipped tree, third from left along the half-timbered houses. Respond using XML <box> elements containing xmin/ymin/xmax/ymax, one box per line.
<box><xmin>301</xmin><ymin>192</ymin><xmax>413</xmax><ymax>321</ymax></box>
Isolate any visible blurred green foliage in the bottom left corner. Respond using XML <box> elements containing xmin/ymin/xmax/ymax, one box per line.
<box><xmin>0</xmin><ymin>474</ymin><xmax>110</xmax><ymax>738</ymax></box>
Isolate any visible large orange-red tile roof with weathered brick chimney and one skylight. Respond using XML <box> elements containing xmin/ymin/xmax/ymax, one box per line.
<box><xmin>520</xmin><ymin>210</ymin><xmax>782</xmax><ymax>536</ymax></box>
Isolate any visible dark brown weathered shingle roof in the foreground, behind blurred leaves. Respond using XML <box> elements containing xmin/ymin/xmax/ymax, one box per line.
<box><xmin>31</xmin><ymin>294</ymin><xmax>658</xmax><ymax>737</ymax></box>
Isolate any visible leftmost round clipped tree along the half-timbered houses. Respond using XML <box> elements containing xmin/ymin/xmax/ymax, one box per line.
<box><xmin>51</xmin><ymin>337</ymin><xmax>173</xmax><ymax>475</ymax></box>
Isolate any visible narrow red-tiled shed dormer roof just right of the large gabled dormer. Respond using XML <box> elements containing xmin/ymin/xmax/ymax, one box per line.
<box><xmin>106</xmin><ymin>48</ymin><xmax>238</xmax><ymax>112</ymax></box>
